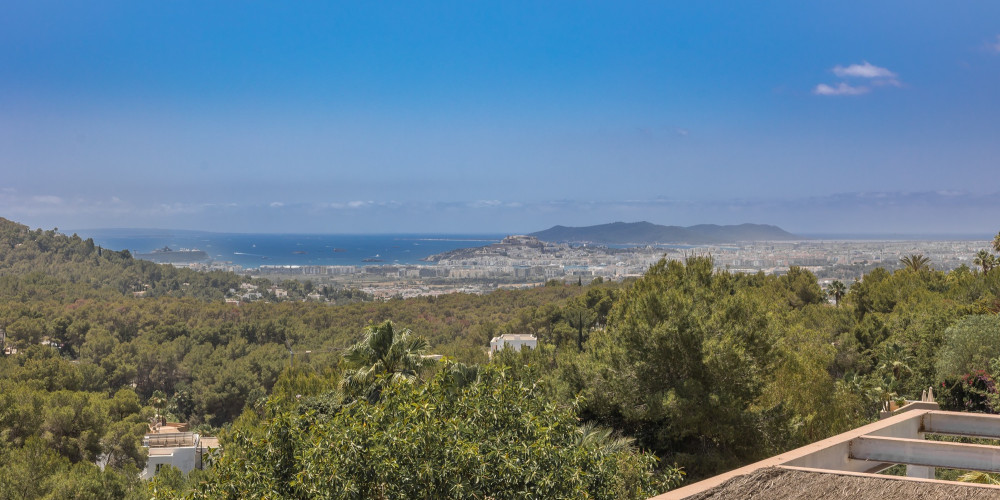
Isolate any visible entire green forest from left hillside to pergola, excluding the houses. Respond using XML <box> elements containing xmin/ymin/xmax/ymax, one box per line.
<box><xmin>0</xmin><ymin>220</ymin><xmax>1000</xmax><ymax>499</ymax></box>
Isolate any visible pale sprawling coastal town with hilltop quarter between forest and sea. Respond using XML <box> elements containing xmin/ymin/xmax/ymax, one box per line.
<box><xmin>156</xmin><ymin>235</ymin><xmax>989</xmax><ymax>300</ymax></box>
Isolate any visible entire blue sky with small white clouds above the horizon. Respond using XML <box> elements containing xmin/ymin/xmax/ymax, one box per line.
<box><xmin>0</xmin><ymin>0</ymin><xmax>1000</xmax><ymax>235</ymax></box>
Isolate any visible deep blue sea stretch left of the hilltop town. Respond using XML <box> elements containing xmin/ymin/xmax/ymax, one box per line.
<box><xmin>76</xmin><ymin>229</ymin><xmax>506</xmax><ymax>268</ymax></box>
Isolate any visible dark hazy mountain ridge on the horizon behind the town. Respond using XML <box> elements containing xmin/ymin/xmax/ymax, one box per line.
<box><xmin>529</xmin><ymin>221</ymin><xmax>803</xmax><ymax>245</ymax></box>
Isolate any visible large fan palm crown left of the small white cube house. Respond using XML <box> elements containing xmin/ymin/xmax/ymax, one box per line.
<box><xmin>341</xmin><ymin>321</ymin><xmax>427</xmax><ymax>397</ymax></box>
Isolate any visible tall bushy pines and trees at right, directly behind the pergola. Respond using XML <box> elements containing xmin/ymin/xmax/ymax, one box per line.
<box><xmin>548</xmin><ymin>258</ymin><xmax>1000</xmax><ymax>477</ymax></box>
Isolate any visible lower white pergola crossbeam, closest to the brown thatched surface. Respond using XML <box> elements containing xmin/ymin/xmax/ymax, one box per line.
<box><xmin>850</xmin><ymin>436</ymin><xmax>1000</xmax><ymax>472</ymax></box>
